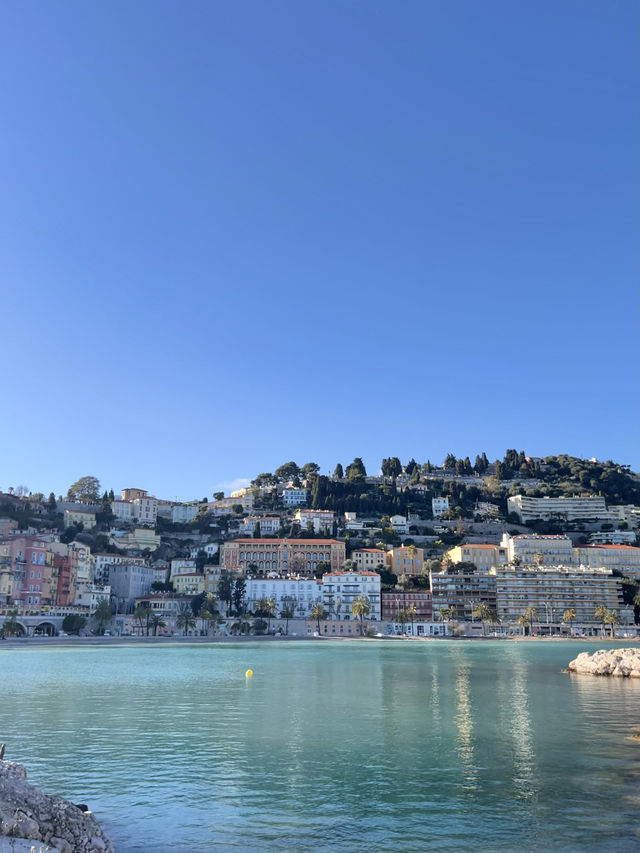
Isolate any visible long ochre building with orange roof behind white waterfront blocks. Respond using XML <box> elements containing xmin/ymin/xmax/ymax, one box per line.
<box><xmin>220</xmin><ymin>538</ymin><xmax>345</xmax><ymax>575</ymax></box>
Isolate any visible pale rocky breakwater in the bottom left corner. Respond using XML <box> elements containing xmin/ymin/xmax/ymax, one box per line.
<box><xmin>0</xmin><ymin>761</ymin><xmax>114</xmax><ymax>853</ymax></box>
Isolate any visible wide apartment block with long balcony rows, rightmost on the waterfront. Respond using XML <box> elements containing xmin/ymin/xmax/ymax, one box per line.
<box><xmin>495</xmin><ymin>566</ymin><xmax>633</xmax><ymax>627</ymax></box>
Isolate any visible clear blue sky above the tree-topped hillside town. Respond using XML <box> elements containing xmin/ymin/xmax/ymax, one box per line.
<box><xmin>0</xmin><ymin>0</ymin><xmax>638</xmax><ymax>499</ymax></box>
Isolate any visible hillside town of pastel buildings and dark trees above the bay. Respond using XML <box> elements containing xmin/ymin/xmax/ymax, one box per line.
<box><xmin>0</xmin><ymin>450</ymin><xmax>640</xmax><ymax>638</ymax></box>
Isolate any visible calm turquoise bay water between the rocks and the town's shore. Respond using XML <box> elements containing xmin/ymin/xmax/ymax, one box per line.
<box><xmin>0</xmin><ymin>641</ymin><xmax>640</xmax><ymax>853</ymax></box>
